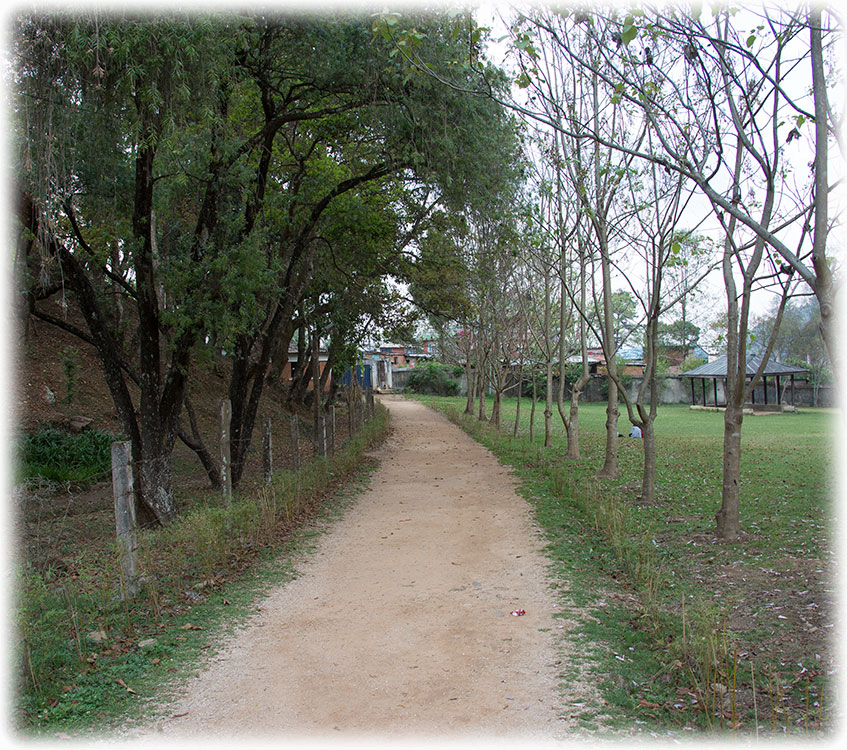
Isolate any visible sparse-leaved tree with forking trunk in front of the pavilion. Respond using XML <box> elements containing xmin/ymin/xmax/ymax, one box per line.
<box><xmin>496</xmin><ymin>6</ymin><xmax>841</xmax><ymax>538</ymax></box>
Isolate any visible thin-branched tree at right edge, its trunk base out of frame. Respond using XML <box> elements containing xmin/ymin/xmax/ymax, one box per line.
<box><xmin>564</xmin><ymin>4</ymin><xmax>844</xmax><ymax>382</ymax></box>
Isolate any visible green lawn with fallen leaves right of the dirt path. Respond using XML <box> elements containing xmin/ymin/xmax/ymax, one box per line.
<box><xmin>420</xmin><ymin>397</ymin><xmax>839</xmax><ymax>736</ymax></box>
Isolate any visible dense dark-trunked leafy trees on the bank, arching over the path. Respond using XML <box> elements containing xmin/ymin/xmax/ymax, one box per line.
<box><xmin>12</xmin><ymin>11</ymin><xmax>517</xmax><ymax>524</ymax></box>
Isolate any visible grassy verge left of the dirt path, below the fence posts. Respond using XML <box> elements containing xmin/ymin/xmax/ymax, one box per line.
<box><xmin>15</xmin><ymin>409</ymin><xmax>389</xmax><ymax>736</ymax></box>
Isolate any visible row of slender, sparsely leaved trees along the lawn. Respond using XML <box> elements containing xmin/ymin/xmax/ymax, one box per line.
<box><xmin>386</xmin><ymin>4</ymin><xmax>843</xmax><ymax>539</ymax></box>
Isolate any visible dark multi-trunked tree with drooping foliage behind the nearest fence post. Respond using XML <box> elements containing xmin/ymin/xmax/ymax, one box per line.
<box><xmin>14</xmin><ymin>14</ymin><xmax>245</xmax><ymax>523</ymax></box>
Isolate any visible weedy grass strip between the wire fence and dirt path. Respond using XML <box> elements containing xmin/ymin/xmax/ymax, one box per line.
<box><xmin>15</xmin><ymin>405</ymin><xmax>388</xmax><ymax>727</ymax></box>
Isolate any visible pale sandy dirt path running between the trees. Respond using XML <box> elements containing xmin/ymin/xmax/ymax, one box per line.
<box><xmin>147</xmin><ymin>396</ymin><xmax>584</xmax><ymax>741</ymax></box>
